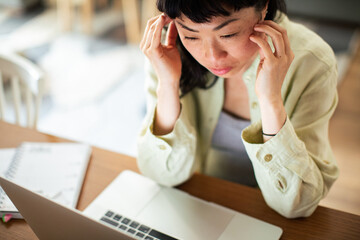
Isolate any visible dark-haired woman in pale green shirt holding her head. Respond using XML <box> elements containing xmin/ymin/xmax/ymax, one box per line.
<box><xmin>138</xmin><ymin>0</ymin><xmax>338</xmax><ymax>218</ymax></box>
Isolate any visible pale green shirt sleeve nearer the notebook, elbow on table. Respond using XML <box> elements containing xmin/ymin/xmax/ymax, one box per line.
<box><xmin>137</xmin><ymin>62</ymin><xmax>197</xmax><ymax>186</ymax></box>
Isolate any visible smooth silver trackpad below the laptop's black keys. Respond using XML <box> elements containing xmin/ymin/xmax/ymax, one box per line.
<box><xmin>136</xmin><ymin>188</ymin><xmax>234</xmax><ymax>239</ymax></box>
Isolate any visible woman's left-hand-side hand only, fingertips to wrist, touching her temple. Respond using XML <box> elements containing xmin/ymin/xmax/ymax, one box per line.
<box><xmin>140</xmin><ymin>14</ymin><xmax>181</xmax><ymax>86</ymax></box>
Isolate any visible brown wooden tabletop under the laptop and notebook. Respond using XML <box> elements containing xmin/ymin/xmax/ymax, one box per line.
<box><xmin>0</xmin><ymin>121</ymin><xmax>360</xmax><ymax>240</ymax></box>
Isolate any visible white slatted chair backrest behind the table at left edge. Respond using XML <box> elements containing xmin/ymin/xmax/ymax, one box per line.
<box><xmin>0</xmin><ymin>53</ymin><xmax>44</xmax><ymax>128</ymax></box>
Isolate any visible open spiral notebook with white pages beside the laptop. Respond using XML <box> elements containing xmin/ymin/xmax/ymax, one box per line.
<box><xmin>0</xmin><ymin>142</ymin><xmax>91</xmax><ymax>218</ymax></box>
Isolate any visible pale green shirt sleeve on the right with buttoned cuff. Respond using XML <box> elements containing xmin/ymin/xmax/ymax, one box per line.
<box><xmin>242</xmin><ymin>53</ymin><xmax>338</xmax><ymax>218</ymax></box>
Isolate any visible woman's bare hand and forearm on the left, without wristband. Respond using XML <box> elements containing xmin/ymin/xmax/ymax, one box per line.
<box><xmin>140</xmin><ymin>14</ymin><xmax>181</xmax><ymax>135</ymax></box>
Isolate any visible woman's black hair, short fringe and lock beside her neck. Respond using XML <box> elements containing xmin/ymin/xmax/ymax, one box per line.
<box><xmin>157</xmin><ymin>0</ymin><xmax>286</xmax><ymax>96</ymax></box>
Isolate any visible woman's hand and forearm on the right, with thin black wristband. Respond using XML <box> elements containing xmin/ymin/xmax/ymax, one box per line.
<box><xmin>250</xmin><ymin>21</ymin><xmax>294</xmax><ymax>142</ymax></box>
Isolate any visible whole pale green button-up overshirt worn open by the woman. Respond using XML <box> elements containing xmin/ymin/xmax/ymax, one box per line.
<box><xmin>137</xmin><ymin>16</ymin><xmax>339</xmax><ymax>218</ymax></box>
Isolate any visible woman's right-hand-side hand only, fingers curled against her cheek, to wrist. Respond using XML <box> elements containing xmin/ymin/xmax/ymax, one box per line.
<box><xmin>250</xmin><ymin>20</ymin><xmax>294</xmax><ymax>102</ymax></box>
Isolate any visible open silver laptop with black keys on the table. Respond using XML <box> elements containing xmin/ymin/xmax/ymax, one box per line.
<box><xmin>0</xmin><ymin>170</ymin><xmax>282</xmax><ymax>240</ymax></box>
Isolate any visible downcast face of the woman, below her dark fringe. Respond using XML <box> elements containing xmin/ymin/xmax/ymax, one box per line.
<box><xmin>175</xmin><ymin>7</ymin><xmax>265</xmax><ymax>78</ymax></box>
